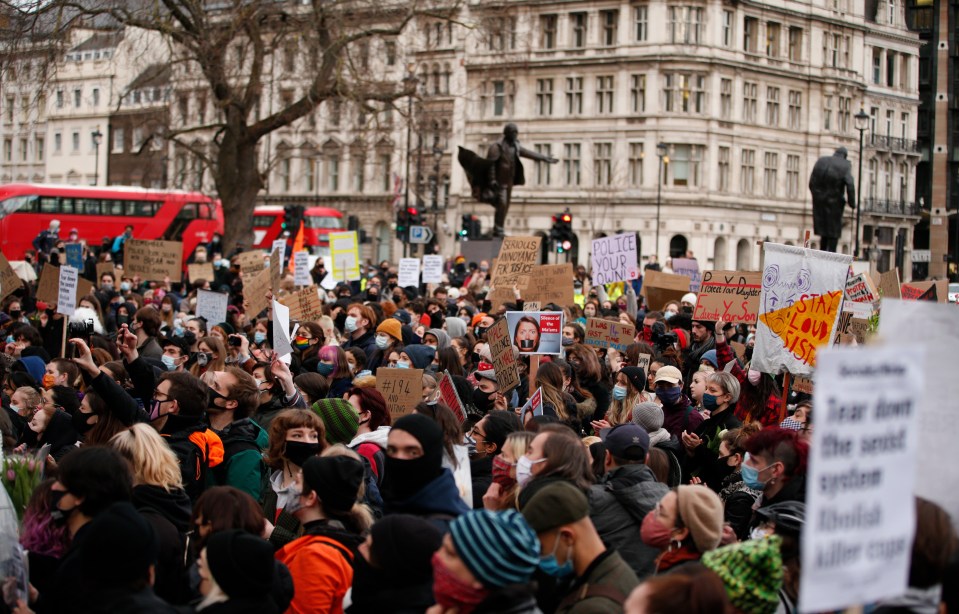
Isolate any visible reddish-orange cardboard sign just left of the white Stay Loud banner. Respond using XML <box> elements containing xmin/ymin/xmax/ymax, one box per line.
<box><xmin>693</xmin><ymin>271</ymin><xmax>762</xmax><ymax>324</ymax></box>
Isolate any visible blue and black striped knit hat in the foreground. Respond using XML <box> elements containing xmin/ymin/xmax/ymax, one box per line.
<box><xmin>450</xmin><ymin>510</ymin><xmax>539</xmax><ymax>589</ymax></box>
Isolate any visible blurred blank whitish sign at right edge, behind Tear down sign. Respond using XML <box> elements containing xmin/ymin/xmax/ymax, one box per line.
<box><xmin>880</xmin><ymin>299</ymin><xmax>959</xmax><ymax>531</ymax></box>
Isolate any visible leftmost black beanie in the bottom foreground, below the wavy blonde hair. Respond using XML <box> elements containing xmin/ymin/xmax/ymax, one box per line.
<box><xmin>80</xmin><ymin>501</ymin><xmax>158</xmax><ymax>588</ymax></box>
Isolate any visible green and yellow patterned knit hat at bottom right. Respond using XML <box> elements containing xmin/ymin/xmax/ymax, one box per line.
<box><xmin>702</xmin><ymin>535</ymin><xmax>783</xmax><ymax>614</ymax></box>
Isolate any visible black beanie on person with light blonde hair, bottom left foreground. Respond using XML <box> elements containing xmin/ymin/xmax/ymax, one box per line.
<box><xmin>206</xmin><ymin>529</ymin><xmax>273</xmax><ymax>600</ymax></box>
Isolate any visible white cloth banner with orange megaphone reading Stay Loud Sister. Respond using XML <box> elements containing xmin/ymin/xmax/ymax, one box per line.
<box><xmin>752</xmin><ymin>242</ymin><xmax>852</xmax><ymax>375</ymax></box>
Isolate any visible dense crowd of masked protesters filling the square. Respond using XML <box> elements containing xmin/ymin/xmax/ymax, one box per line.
<box><xmin>0</xmin><ymin>232</ymin><xmax>959</xmax><ymax>614</ymax></box>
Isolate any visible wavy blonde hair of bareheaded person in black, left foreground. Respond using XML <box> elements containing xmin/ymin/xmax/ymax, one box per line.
<box><xmin>110</xmin><ymin>422</ymin><xmax>183</xmax><ymax>492</ymax></box>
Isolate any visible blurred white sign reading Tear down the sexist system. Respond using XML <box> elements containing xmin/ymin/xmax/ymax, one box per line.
<box><xmin>799</xmin><ymin>345</ymin><xmax>928</xmax><ymax>612</ymax></box>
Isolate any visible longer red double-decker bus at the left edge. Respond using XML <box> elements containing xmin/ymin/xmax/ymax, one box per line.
<box><xmin>0</xmin><ymin>183</ymin><xmax>223</xmax><ymax>262</ymax></box>
